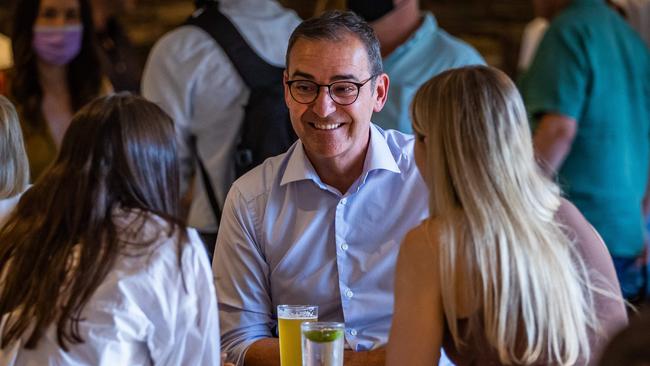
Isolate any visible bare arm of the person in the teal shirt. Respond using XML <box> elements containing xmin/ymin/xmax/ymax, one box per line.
<box><xmin>533</xmin><ymin>113</ymin><xmax>578</xmax><ymax>176</ymax></box>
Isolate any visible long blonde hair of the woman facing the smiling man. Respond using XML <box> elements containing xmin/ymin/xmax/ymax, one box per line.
<box><xmin>412</xmin><ymin>66</ymin><xmax>598</xmax><ymax>364</ymax></box>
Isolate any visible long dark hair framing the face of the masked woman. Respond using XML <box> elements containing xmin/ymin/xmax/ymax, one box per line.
<box><xmin>9</xmin><ymin>0</ymin><xmax>102</xmax><ymax>123</ymax></box>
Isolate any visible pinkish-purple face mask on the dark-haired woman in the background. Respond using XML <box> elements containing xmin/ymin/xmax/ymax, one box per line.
<box><xmin>32</xmin><ymin>24</ymin><xmax>83</xmax><ymax>66</ymax></box>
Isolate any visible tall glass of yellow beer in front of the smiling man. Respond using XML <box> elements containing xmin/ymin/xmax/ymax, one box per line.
<box><xmin>278</xmin><ymin>305</ymin><xmax>318</xmax><ymax>366</ymax></box>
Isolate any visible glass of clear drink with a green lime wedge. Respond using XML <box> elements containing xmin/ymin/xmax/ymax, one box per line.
<box><xmin>300</xmin><ymin>322</ymin><xmax>345</xmax><ymax>366</ymax></box>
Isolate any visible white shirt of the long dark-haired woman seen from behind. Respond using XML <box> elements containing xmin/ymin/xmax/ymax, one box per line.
<box><xmin>0</xmin><ymin>213</ymin><xmax>220</xmax><ymax>366</ymax></box>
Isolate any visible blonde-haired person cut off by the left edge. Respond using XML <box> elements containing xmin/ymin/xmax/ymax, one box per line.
<box><xmin>0</xmin><ymin>96</ymin><xmax>29</xmax><ymax>226</ymax></box>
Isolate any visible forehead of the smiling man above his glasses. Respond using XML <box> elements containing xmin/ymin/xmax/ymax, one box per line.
<box><xmin>287</xmin><ymin>36</ymin><xmax>370</xmax><ymax>81</ymax></box>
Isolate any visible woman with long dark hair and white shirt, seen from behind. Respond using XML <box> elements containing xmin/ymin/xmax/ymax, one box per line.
<box><xmin>0</xmin><ymin>95</ymin><xmax>220</xmax><ymax>366</ymax></box>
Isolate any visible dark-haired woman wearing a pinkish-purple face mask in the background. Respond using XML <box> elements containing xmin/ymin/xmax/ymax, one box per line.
<box><xmin>0</xmin><ymin>0</ymin><xmax>111</xmax><ymax>180</ymax></box>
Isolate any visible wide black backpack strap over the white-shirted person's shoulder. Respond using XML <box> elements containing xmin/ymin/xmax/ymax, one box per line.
<box><xmin>186</xmin><ymin>1</ymin><xmax>284</xmax><ymax>89</ymax></box>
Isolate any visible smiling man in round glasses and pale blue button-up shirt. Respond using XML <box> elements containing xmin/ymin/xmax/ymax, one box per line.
<box><xmin>213</xmin><ymin>12</ymin><xmax>428</xmax><ymax>365</ymax></box>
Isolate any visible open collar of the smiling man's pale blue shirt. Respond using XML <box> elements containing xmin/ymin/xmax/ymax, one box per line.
<box><xmin>280</xmin><ymin>123</ymin><xmax>401</xmax><ymax>186</ymax></box>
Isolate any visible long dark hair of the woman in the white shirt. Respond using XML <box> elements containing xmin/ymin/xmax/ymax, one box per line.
<box><xmin>0</xmin><ymin>94</ymin><xmax>187</xmax><ymax>349</ymax></box>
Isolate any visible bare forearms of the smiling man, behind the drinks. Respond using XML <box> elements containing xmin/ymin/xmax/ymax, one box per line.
<box><xmin>244</xmin><ymin>338</ymin><xmax>386</xmax><ymax>366</ymax></box>
